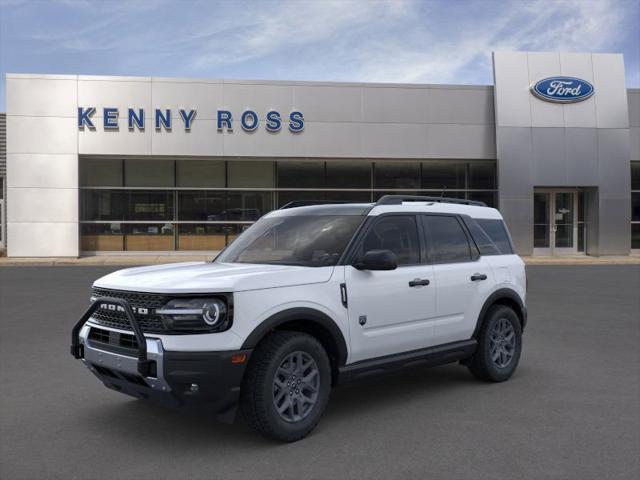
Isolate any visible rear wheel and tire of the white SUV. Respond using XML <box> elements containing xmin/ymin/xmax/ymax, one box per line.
<box><xmin>469</xmin><ymin>305</ymin><xmax>522</xmax><ymax>382</ymax></box>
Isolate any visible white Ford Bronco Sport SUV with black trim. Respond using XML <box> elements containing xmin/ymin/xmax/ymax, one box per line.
<box><xmin>71</xmin><ymin>195</ymin><xmax>527</xmax><ymax>441</ymax></box>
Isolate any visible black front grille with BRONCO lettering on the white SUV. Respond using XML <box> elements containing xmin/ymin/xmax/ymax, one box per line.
<box><xmin>91</xmin><ymin>288</ymin><xmax>169</xmax><ymax>333</ymax></box>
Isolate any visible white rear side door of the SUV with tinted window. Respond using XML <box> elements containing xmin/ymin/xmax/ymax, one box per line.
<box><xmin>421</xmin><ymin>215</ymin><xmax>495</xmax><ymax>345</ymax></box>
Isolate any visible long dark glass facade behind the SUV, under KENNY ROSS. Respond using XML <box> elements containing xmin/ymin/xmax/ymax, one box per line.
<box><xmin>80</xmin><ymin>157</ymin><xmax>497</xmax><ymax>252</ymax></box>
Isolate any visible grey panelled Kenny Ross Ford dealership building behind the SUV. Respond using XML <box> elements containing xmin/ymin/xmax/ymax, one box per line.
<box><xmin>0</xmin><ymin>52</ymin><xmax>640</xmax><ymax>257</ymax></box>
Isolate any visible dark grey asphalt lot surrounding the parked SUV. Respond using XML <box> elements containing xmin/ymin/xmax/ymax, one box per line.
<box><xmin>0</xmin><ymin>265</ymin><xmax>640</xmax><ymax>480</ymax></box>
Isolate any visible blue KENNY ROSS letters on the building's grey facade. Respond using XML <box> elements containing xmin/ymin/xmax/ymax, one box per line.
<box><xmin>78</xmin><ymin>107</ymin><xmax>304</xmax><ymax>133</ymax></box>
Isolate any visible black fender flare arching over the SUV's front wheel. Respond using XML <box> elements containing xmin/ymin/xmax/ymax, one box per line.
<box><xmin>242</xmin><ymin>307</ymin><xmax>348</xmax><ymax>366</ymax></box>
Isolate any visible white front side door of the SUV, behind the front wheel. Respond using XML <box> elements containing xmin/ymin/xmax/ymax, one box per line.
<box><xmin>345</xmin><ymin>214</ymin><xmax>436</xmax><ymax>362</ymax></box>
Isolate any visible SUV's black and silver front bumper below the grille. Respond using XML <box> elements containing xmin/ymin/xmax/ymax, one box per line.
<box><xmin>71</xmin><ymin>298</ymin><xmax>252</xmax><ymax>422</ymax></box>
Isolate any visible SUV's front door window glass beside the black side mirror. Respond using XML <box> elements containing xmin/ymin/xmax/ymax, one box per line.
<box><xmin>362</xmin><ymin>215</ymin><xmax>420</xmax><ymax>265</ymax></box>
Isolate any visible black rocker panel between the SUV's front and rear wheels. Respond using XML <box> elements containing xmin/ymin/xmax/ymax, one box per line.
<box><xmin>338</xmin><ymin>339</ymin><xmax>478</xmax><ymax>383</ymax></box>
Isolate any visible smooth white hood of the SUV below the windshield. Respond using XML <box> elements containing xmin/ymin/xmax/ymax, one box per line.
<box><xmin>93</xmin><ymin>262</ymin><xmax>334</xmax><ymax>293</ymax></box>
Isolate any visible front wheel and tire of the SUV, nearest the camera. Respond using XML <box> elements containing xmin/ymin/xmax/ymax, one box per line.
<box><xmin>240</xmin><ymin>331</ymin><xmax>331</xmax><ymax>442</ymax></box>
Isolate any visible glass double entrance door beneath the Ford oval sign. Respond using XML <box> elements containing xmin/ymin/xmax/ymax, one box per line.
<box><xmin>533</xmin><ymin>190</ymin><xmax>578</xmax><ymax>255</ymax></box>
